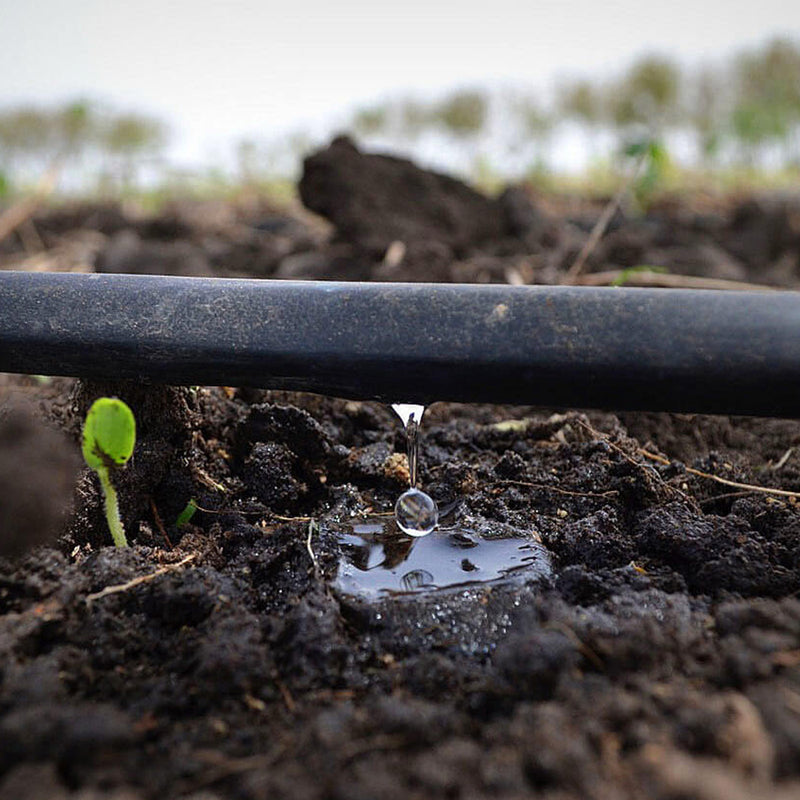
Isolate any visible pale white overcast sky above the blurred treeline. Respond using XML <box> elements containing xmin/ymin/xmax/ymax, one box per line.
<box><xmin>0</xmin><ymin>0</ymin><xmax>800</xmax><ymax>166</ymax></box>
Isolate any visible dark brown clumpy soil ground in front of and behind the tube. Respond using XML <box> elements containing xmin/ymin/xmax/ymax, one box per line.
<box><xmin>0</xmin><ymin>140</ymin><xmax>800</xmax><ymax>800</ymax></box>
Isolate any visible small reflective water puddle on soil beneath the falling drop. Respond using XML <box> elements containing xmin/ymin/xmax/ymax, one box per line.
<box><xmin>334</xmin><ymin>517</ymin><xmax>551</xmax><ymax>599</ymax></box>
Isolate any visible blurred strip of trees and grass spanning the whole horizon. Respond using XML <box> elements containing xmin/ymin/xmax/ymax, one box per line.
<box><xmin>0</xmin><ymin>39</ymin><xmax>800</xmax><ymax>207</ymax></box>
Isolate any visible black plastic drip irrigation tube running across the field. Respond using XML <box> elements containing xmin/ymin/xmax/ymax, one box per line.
<box><xmin>0</xmin><ymin>271</ymin><xmax>800</xmax><ymax>416</ymax></box>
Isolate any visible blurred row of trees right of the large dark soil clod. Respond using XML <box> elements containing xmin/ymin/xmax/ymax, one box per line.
<box><xmin>340</xmin><ymin>39</ymin><xmax>800</xmax><ymax>192</ymax></box>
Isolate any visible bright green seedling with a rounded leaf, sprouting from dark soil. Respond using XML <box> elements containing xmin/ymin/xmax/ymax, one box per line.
<box><xmin>83</xmin><ymin>397</ymin><xmax>136</xmax><ymax>547</ymax></box>
